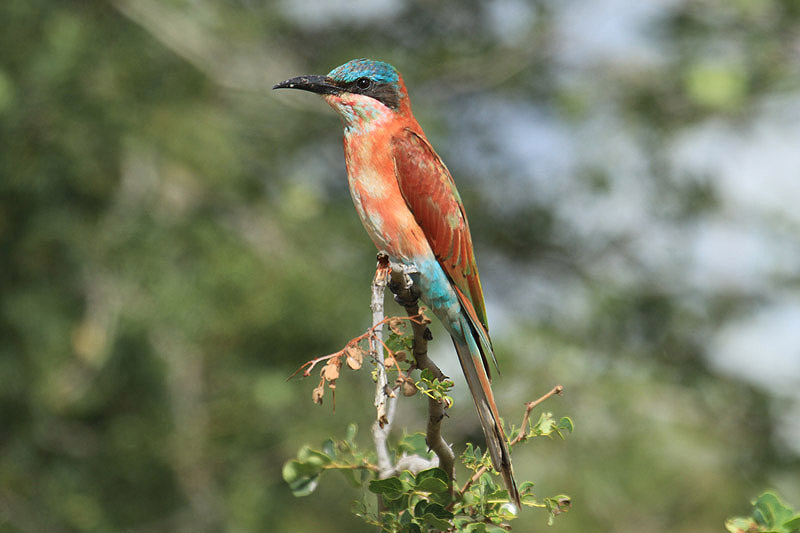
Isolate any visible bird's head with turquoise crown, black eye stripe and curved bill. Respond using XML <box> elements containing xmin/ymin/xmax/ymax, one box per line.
<box><xmin>273</xmin><ymin>59</ymin><xmax>411</xmax><ymax>129</ymax></box>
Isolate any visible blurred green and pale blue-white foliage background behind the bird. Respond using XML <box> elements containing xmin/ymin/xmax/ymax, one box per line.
<box><xmin>0</xmin><ymin>0</ymin><xmax>800</xmax><ymax>533</ymax></box>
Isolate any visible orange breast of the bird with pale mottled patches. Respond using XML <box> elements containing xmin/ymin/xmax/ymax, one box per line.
<box><xmin>345</xmin><ymin>134</ymin><xmax>430</xmax><ymax>262</ymax></box>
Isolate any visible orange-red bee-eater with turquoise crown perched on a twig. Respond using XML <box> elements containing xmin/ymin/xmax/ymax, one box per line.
<box><xmin>273</xmin><ymin>59</ymin><xmax>519</xmax><ymax>506</ymax></box>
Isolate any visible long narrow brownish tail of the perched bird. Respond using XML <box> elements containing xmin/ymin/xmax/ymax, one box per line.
<box><xmin>453</xmin><ymin>317</ymin><xmax>520</xmax><ymax>507</ymax></box>
